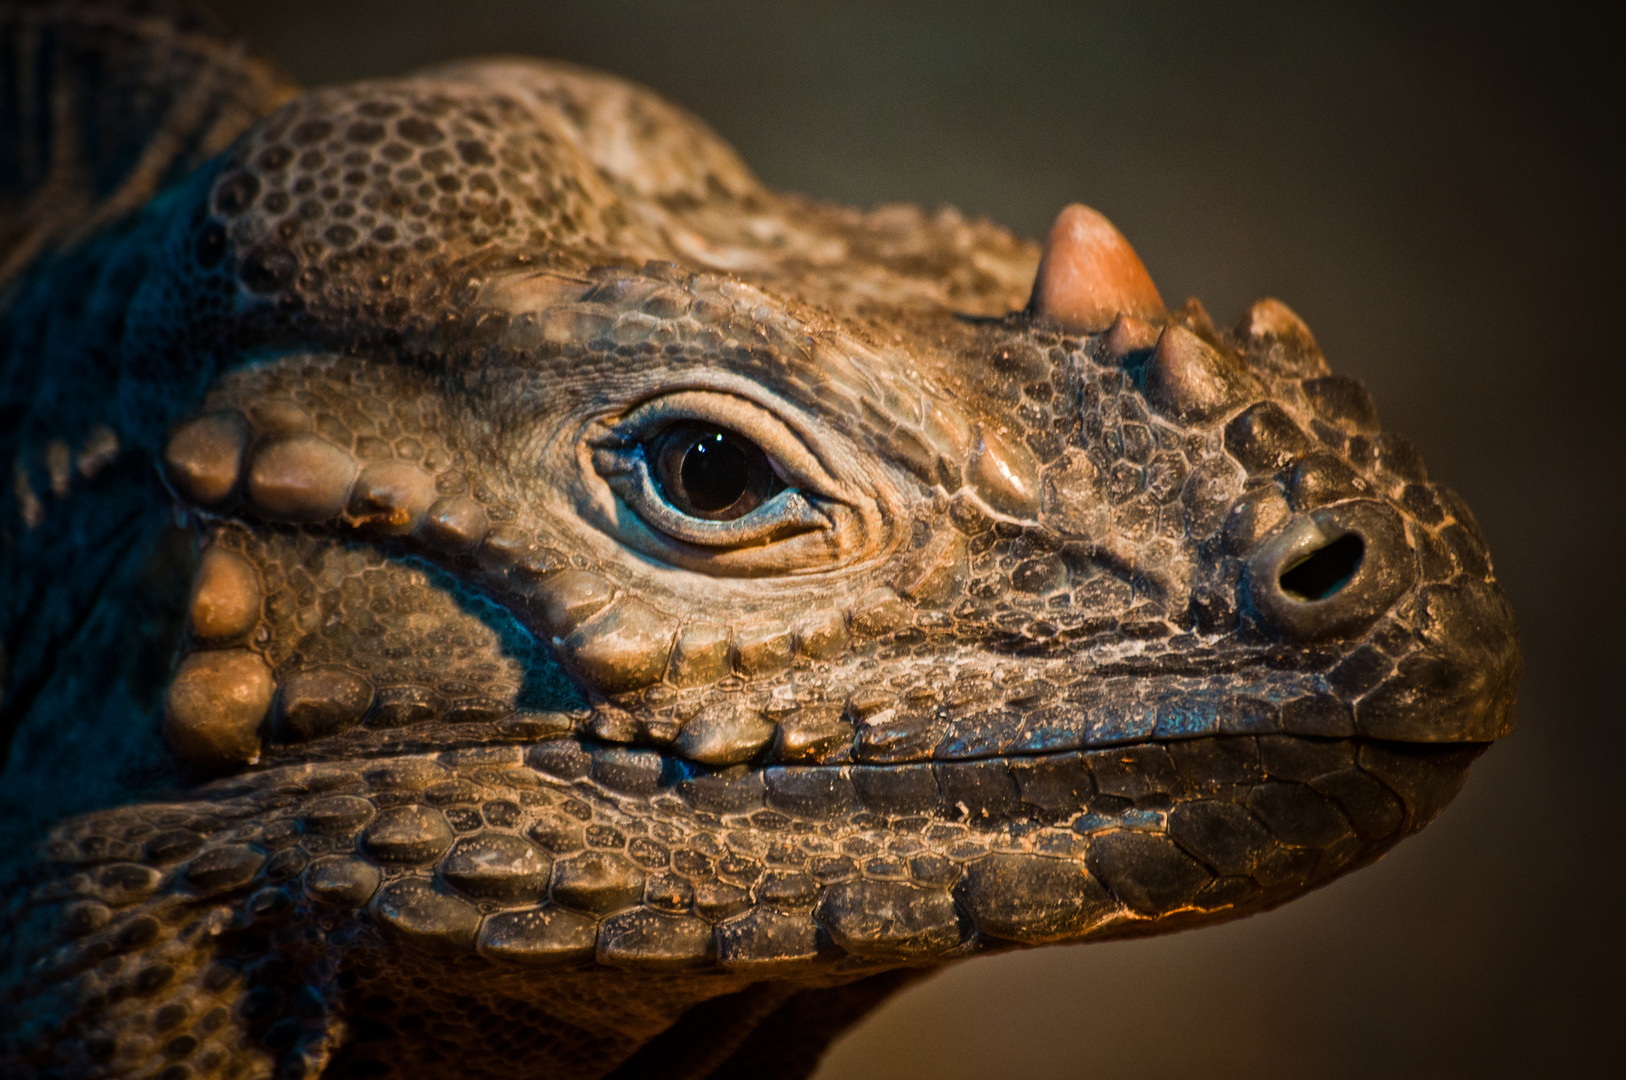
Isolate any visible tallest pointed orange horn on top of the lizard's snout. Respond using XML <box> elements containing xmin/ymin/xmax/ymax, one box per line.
<box><xmin>1028</xmin><ymin>203</ymin><xmax>1169</xmax><ymax>333</ymax></box>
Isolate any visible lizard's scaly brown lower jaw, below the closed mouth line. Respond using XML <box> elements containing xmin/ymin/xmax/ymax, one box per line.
<box><xmin>117</xmin><ymin>735</ymin><xmax>1483</xmax><ymax>981</ymax></box>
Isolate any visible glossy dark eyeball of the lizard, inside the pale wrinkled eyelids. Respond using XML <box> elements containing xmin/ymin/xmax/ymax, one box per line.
<box><xmin>646</xmin><ymin>423</ymin><xmax>785</xmax><ymax>520</ymax></box>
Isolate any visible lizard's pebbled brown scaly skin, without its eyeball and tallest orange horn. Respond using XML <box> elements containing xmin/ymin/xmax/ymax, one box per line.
<box><xmin>0</xmin><ymin>5</ymin><xmax>1519</xmax><ymax>1080</ymax></box>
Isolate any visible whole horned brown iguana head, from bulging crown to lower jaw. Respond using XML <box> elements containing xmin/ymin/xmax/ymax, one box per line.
<box><xmin>0</xmin><ymin>48</ymin><xmax>1517</xmax><ymax>1073</ymax></box>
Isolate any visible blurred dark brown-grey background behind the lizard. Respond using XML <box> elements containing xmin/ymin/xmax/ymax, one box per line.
<box><xmin>203</xmin><ymin>0</ymin><xmax>1626</xmax><ymax>1080</ymax></box>
